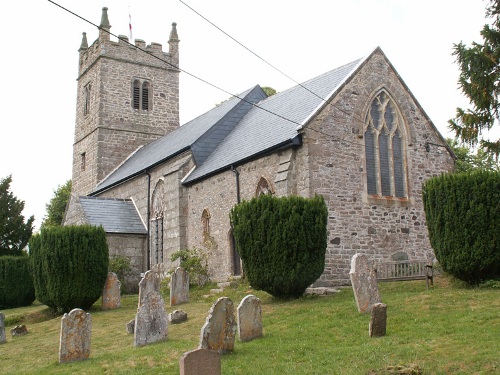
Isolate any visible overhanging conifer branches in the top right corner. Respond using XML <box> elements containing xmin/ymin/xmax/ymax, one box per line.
<box><xmin>448</xmin><ymin>0</ymin><xmax>500</xmax><ymax>158</ymax></box>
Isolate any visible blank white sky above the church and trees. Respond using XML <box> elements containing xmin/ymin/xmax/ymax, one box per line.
<box><xmin>0</xmin><ymin>0</ymin><xmax>488</xmax><ymax>230</ymax></box>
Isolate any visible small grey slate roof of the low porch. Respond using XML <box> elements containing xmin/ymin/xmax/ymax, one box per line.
<box><xmin>78</xmin><ymin>196</ymin><xmax>147</xmax><ymax>234</ymax></box>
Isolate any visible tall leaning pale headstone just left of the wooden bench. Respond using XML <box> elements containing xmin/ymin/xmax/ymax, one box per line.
<box><xmin>349</xmin><ymin>254</ymin><xmax>381</xmax><ymax>313</ymax></box>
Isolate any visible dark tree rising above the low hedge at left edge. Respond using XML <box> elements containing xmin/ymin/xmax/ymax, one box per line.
<box><xmin>0</xmin><ymin>176</ymin><xmax>35</xmax><ymax>256</ymax></box>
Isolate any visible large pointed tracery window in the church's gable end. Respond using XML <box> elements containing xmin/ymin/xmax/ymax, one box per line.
<box><xmin>364</xmin><ymin>91</ymin><xmax>408</xmax><ymax>198</ymax></box>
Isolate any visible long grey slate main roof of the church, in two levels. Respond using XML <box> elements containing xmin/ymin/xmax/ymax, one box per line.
<box><xmin>93</xmin><ymin>52</ymin><xmax>365</xmax><ymax>194</ymax></box>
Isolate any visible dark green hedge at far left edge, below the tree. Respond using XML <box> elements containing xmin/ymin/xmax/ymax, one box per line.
<box><xmin>0</xmin><ymin>255</ymin><xmax>35</xmax><ymax>309</ymax></box>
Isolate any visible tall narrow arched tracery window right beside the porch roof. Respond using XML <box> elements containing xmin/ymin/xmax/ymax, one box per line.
<box><xmin>150</xmin><ymin>180</ymin><xmax>165</xmax><ymax>265</ymax></box>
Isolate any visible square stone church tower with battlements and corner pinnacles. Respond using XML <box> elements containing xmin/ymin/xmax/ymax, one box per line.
<box><xmin>72</xmin><ymin>8</ymin><xmax>179</xmax><ymax>195</ymax></box>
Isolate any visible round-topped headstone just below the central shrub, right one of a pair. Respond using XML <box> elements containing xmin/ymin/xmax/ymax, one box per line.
<box><xmin>237</xmin><ymin>294</ymin><xmax>262</xmax><ymax>341</ymax></box>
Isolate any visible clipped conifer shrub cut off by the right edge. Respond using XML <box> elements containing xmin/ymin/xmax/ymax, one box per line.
<box><xmin>423</xmin><ymin>171</ymin><xmax>500</xmax><ymax>284</ymax></box>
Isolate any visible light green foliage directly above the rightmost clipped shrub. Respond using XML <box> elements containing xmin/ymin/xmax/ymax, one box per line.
<box><xmin>446</xmin><ymin>138</ymin><xmax>500</xmax><ymax>173</ymax></box>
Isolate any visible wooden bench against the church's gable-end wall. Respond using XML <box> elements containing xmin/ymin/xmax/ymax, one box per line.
<box><xmin>375</xmin><ymin>260</ymin><xmax>434</xmax><ymax>289</ymax></box>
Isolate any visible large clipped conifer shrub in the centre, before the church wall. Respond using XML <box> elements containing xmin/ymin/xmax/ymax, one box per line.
<box><xmin>230</xmin><ymin>195</ymin><xmax>328</xmax><ymax>298</ymax></box>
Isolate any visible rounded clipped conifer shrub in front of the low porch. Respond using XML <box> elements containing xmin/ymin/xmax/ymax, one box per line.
<box><xmin>30</xmin><ymin>225</ymin><xmax>109</xmax><ymax>312</ymax></box>
